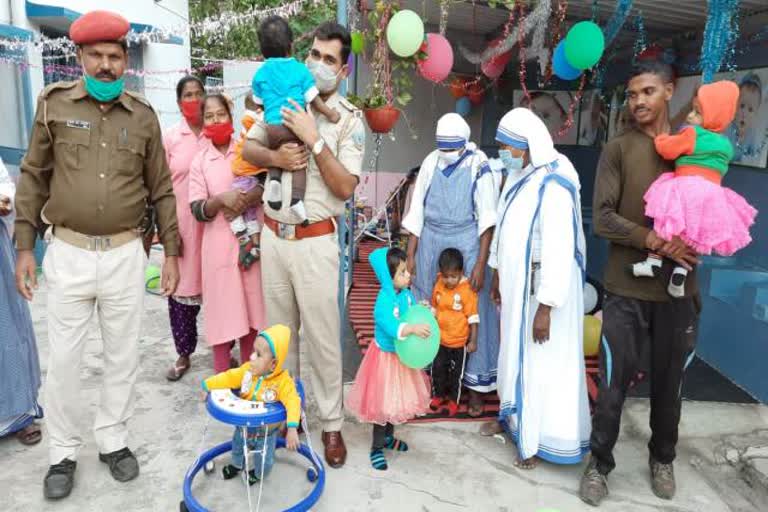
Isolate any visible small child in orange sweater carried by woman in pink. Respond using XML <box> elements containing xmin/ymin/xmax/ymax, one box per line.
<box><xmin>229</xmin><ymin>94</ymin><xmax>267</xmax><ymax>270</ymax></box>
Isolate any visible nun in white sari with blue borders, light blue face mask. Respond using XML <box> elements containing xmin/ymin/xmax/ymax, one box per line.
<box><xmin>489</xmin><ymin>108</ymin><xmax>590</xmax><ymax>469</ymax></box>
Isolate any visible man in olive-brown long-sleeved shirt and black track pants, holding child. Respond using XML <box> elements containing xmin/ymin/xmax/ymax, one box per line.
<box><xmin>580</xmin><ymin>61</ymin><xmax>701</xmax><ymax>505</ymax></box>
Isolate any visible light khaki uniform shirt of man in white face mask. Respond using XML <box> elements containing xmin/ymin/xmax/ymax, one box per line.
<box><xmin>248</xmin><ymin>93</ymin><xmax>365</xmax><ymax>224</ymax></box>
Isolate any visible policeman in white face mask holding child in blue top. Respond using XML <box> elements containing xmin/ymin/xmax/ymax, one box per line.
<box><xmin>243</xmin><ymin>22</ymin><xmax>365</xmax><ymax>468</ymax></box>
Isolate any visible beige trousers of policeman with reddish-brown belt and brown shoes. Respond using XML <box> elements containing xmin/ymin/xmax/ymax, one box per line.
<box><xmin>261</xmin><ymin>228</ymin><xmax>343</xmax><ymax>432</ymax></box>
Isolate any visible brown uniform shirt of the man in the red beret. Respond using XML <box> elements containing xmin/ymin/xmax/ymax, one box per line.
<box><xmin>16</xmin><ymin>80</ymin><xmax>179</xmax><ymax>256</ymax></box>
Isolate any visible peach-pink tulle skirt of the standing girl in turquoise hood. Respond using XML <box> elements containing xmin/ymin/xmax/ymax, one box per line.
<box><xmin>344</xmin><ymin>342</ymin><xmax>431</xmax><ymax>425</ymax></box>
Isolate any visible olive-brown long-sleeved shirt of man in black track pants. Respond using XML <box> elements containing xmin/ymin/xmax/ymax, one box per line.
<box><xmin>592</xmin><ymin>127</ymin><xmax>698</xmax><ymax>302</ymax></box>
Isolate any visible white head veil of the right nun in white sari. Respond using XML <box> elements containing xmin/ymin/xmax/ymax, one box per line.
<box><xmin>496</xmin><ymin>108</ymin><xmax>559</xmax><ymax>167</ymax></box>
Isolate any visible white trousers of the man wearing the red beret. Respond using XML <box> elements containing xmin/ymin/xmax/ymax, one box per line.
<box><xmin>43</xmin><ymin>236</ymin><xmax>147</xmax><ymax>464</ymax></box>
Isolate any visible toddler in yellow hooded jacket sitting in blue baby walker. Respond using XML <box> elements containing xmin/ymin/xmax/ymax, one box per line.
<box><xmin>203</xmin><ymin>324</ymin><xmax>301</xmax><ymax>484</ymax></box>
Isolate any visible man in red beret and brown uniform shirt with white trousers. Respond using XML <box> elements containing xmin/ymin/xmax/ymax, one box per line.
<box><xmin>16</xmin><ymin>11</ymin><xmax>179</xmax><ymax>499</ymax></box>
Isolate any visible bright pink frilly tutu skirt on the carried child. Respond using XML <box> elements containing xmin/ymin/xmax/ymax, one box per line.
<box><xmin>644</xmin><ymin>172</ymin><xmax>757</xmax><ymax>256</ymax></box>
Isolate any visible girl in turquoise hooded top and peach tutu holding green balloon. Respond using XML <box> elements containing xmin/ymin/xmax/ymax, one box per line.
<box><xmin>345</xmin><ymin>247</ymin><xmax>430</xmax><ymax>471</ymax></box>
